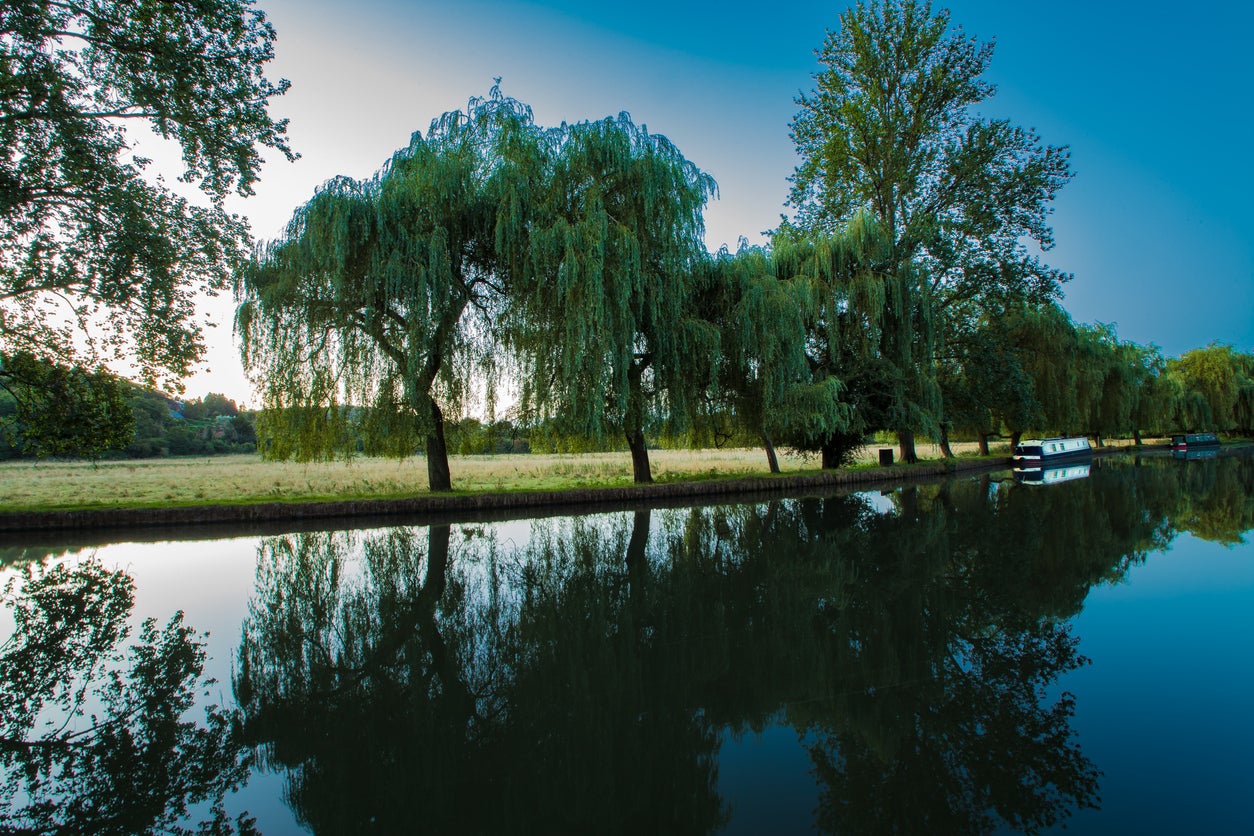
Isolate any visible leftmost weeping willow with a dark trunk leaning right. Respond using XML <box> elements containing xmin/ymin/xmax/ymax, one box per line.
<box><xmin>236</xmin><ymin>86</ymin><xmax>542</xmax><ymax>490</ymax></box>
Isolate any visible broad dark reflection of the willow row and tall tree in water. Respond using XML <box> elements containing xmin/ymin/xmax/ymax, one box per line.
<box><xmin>234</xmin><ymin>457</ymin><xmax>1254</xmax><ymax>833</ymax></box>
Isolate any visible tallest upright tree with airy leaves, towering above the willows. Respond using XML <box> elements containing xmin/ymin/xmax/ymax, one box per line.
<box><xmin>790</xmin><ymin>0</ymin><xmax>1071</xmax><ymax>461</ymax></box>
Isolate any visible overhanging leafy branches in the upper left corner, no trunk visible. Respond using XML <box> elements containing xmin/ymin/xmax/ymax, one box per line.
<box><xmin>0</xmin><ymin>0</ymin><xmax>293</xmax><ymax>400</ymax></box>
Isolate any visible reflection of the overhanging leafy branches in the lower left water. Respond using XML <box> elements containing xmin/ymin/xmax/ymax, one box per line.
<box><xmin>0</xmin><ymin>559</ymin><xmax>253</xmax><ymax>833</ymax></box>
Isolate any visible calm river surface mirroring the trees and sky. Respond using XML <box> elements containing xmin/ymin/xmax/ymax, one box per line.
<box><xmin>0</xmin><ymin>451</ymin><xmax>1254</xmax><ymax>833</ymax></box>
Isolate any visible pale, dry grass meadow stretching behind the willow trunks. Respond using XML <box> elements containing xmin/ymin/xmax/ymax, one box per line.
<box><xmin>0</xmin><ymin>444</ymin><xmax>1128</xmax><ymax>511</ymax></box>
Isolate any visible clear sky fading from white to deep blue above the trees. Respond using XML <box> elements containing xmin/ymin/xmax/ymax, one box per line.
<box><xmin>179</xmin><ymin>0</ymin><xmax>1254</xmax><ymax>406</ymax></box>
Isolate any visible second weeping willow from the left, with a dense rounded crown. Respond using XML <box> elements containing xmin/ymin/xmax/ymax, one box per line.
<box><xmin>503</xmin><ymin>113</ymin><xmax>717</xmax><ymax>483</ymax></box>
